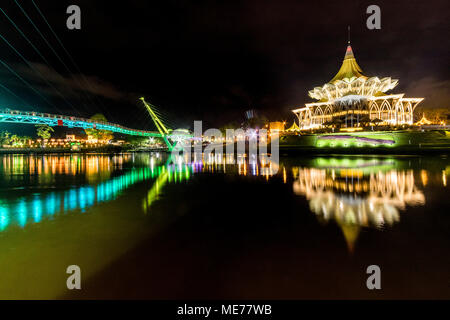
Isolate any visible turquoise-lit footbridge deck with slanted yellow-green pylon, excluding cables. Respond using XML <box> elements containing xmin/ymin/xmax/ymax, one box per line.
<box><xmin>0</xmin><ymin>98</ymin><xmax>192</xmax><ymax>150</ymax></box>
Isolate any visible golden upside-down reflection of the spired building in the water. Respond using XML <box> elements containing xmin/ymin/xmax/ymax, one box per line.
<box><xmin>293</xmin><ymin>158</ymin><xmax>426</xmax><ymax>251</ymax></box>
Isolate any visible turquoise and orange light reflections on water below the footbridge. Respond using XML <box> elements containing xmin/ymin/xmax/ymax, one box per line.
<box><xmin>0</xmin><ymin>154</ymin><xmax>190</xmax><ymax>231</ymax></box>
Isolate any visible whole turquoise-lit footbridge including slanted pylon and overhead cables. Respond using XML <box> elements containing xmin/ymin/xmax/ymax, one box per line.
<box><xmin>0</xmin><ymin>0</ymin><xmax>192</xmax><ymax>150</ymax></box>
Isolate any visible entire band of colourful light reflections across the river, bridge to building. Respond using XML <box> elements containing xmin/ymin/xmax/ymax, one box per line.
<box><xmin>0</xmin><ymin>153</ymin><xmax>450</xmax><ymax>255</ymax></box>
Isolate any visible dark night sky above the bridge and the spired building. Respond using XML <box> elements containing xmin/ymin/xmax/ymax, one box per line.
<box><xmin>0</xmin><ymin>0</ymin><xmax>450</xmax><ymax>128</ymax></box>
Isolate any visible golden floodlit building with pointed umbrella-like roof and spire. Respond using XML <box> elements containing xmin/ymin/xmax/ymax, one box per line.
<box><xmin>292</xmin><ymin>41</ymin><xmax>423</xmax><ymax>130</ymax></box>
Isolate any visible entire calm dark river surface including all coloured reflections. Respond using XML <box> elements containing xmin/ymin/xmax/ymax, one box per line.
<box><xmin>0</xmin><ymin>153</ymin><xmax>450</xmax><ymax>299</ymax></box>
